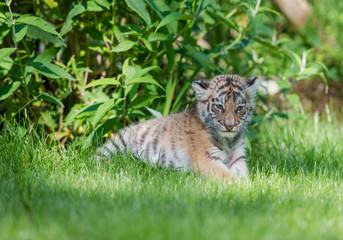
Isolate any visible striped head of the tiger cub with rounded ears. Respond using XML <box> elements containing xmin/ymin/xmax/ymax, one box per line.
<box><xmin>192</xmin><ymin>75</ymin><xmax>258</xmax><ymax>137</ymax></box>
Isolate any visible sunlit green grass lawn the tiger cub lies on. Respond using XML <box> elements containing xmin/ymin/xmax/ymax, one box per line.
<box><xmin>0</xmin><ymin>116</ymin><xmax>343</xmax><ymax>240</ymax></box>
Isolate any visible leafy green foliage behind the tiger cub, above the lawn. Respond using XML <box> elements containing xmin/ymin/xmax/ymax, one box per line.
<box><xmin>0</xmin><ymin>0</ymin><xmax>343</xmax><ymax>145</ymax></box>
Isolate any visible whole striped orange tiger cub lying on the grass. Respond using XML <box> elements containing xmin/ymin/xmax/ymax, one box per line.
<box><xmin>98</xmin><ymin>75</ymin><xmax>258</xmax><ymax>180</ymax></box>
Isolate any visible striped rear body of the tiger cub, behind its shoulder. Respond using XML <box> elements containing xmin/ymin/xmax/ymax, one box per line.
<box><xmin>100</xmin><ymin>111</ymin><xmax>202</xmax><ymax>171</ymax></box>
